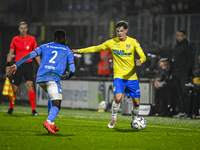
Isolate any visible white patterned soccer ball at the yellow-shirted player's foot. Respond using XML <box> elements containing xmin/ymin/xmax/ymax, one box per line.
<box><xmin>131</xmin><ymin>117</ymin><xmax>147</xmax><ymax>130</ymax></box>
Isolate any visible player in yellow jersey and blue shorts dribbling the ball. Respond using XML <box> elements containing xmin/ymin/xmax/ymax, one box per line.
<box><xmin>72</xmin><ymin>20</ymin><xmax>146</xmax><ymax>128</ymax></box>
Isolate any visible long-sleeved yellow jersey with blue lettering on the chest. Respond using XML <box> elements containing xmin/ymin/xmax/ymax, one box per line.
<box><xmin>78</xmin><ymin>36</ymin><xmax>146</xmax><ymax>80</ymax></box>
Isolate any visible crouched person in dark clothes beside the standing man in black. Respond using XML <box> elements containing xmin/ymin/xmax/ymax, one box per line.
<box><xmin>154</xmin><ymin>58</ymin><xmax>177</xmax><ymax>117</ymax></box>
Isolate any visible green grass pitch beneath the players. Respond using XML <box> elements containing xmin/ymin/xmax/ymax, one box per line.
<box><xmin>0</xmin><ymin>105</ymin><xmax>200</xmax><ymax>150</ymax></box>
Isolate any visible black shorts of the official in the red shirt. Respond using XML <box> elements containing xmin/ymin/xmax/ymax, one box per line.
<box><xmin>12</xmin><ymin>62</ymin><xmax>33</xmax><ymax>86</ymax></box>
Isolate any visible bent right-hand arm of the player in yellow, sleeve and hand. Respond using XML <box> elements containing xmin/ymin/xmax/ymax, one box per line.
<box><xmin>135</xmin><ymin>41</ymin><xmax>146</xmax><ymax>66</ymax></box>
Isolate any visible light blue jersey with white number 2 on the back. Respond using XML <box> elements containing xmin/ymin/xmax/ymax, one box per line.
<box><xmin>35</xmin><ymin>42</ymin><xmax>74</xmax><ymax>82</ymax></box>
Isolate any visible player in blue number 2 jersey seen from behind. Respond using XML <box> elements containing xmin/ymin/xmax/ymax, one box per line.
<box><xmin>6</xmin><ymin>29</ymin><xmax>75</xmax><ymax>134</ymax></box>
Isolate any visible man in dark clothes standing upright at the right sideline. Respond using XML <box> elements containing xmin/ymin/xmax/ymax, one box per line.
<box><xmin>173</xmin><ymin>30</ymin><xmax>194</xmax><ymax>118</ymax></box>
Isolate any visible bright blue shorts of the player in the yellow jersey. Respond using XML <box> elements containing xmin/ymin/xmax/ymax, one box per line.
<box><xmin>113</xmin><ymin>78</ymin><xmax>140</xmax><ymax>98</ymax></box>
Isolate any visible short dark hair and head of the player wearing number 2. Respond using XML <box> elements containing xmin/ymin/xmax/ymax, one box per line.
<box><xmin>54</xmin><ymin>29</ymin><xmax>67</xmax><ymax>45</ymax></box>
